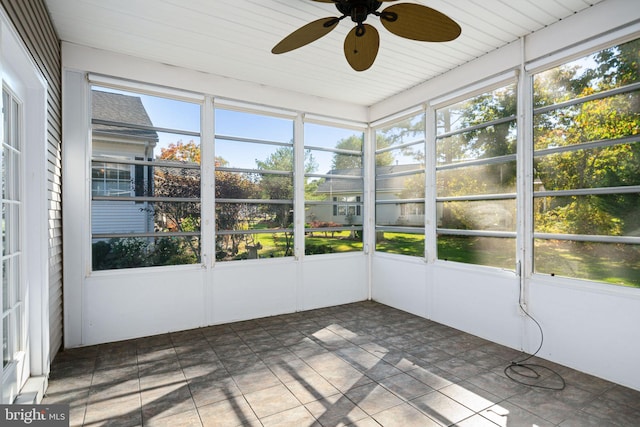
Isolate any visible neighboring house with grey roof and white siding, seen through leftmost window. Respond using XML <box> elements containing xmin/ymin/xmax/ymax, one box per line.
<box><xmin>91</xmin><ymin>90</ymin><xmax>158</xmax><ymax>235</ymax></box>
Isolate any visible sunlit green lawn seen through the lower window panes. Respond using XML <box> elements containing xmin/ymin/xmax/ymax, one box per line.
<box><xmin>224</xmin><ymin>231</ymin><xmax>640</xmax><ymax>288</ymax></box>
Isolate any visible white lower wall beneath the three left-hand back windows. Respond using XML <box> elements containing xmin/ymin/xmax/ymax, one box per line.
<box><xmin>80</xmin><ymin>253</ymin><xmax>367</xmax><ymax>347</ymax></box>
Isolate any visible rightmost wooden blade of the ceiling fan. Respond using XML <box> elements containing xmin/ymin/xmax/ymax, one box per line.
<box><xmin>380</xmin><ymin>3</ymin><xmax>462</xmax><ymax>42</ymax></box>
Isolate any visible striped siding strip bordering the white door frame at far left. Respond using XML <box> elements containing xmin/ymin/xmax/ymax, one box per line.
<box><xmin>0</xmin><ymin>0</ymin><xmax>63</xmax><ymax>359</ymax></box>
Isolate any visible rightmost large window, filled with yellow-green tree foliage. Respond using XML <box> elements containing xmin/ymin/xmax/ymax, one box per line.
<box><xmin>533</xmin><ymin>40</ymin><xmax>640</xmax><ymax>287</ymax></box>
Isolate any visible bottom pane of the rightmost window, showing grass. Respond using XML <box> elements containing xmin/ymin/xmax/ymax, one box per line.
<box><xmin>534</xmin><ymin>239</ymin><xmax>640</xmax><ymax>288</ymax></box>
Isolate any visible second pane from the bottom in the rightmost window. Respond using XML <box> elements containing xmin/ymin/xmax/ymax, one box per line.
<box><xmin>533</xmin><ymin>193</ymin><xmax>640</xmax><ymax>236</ymax></box>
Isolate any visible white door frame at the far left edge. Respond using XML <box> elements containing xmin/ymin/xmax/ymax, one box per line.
<box><xmin>0</xmin><ymin>8</ymin><xmax>52</xmax><ymax>403</ymax></box>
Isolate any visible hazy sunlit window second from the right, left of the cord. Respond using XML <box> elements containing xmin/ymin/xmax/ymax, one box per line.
<box><xmin>436</xmin><ymin>85</ymin><xmax>517</xmax><ymax>269</ymax></box>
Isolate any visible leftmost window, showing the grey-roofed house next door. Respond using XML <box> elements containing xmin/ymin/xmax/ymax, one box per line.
<box><xmin>91</xmin><ymin>86</ymin><xmax>201</xmax><ymax>270</ymax></box>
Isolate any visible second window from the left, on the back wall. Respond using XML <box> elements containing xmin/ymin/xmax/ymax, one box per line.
<box><xmin>215</xmin><ymin>108</ymin><xmax>294</xmax><ymax>261</ymax></box>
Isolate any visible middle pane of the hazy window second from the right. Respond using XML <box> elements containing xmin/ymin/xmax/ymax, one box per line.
<box><xmin>436</xmin><ymin>161</ymin><xmax>517</xmax><ymax>197</ymax></box>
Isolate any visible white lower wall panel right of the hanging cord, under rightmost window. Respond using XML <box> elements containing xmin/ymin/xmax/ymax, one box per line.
<box><xmin>529</xmin><ymin>276</ymin><xmax>640</xmax><ymax>390</ymax></box>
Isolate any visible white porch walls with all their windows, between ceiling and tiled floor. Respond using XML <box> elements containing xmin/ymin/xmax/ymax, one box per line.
<box><xmin>53</xmin><ymin>0</ymin><xmax>640</xmax><ymax>402</ymax></box>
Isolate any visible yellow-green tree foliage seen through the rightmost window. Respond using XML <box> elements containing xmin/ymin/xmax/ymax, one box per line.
<box><xmin>534</xmin><ymin>40</ymin><xmax>640</xmax><ymax>235</ymax></box>
